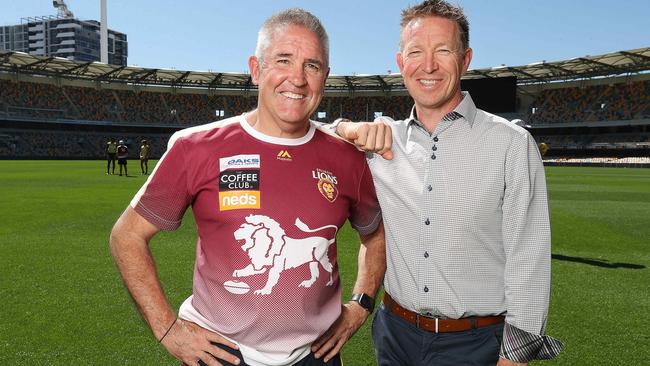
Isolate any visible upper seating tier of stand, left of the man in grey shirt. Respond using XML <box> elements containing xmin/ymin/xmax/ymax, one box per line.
<box><xmin>0</xmin><ymin>80</ymin><xmax>413</xmax><ymax>126</ymax></box>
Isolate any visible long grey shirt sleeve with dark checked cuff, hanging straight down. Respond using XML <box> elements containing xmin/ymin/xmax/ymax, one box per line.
<box><xmin>498</xmin><ymin>133</ymin><xmax>562</xmax><ymax>366</ymax></box>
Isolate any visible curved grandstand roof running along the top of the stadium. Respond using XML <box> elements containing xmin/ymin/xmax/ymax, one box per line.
<box><xmin>0</xmin><ymin>47</ymin><xmax>650</xmax><ymax>91</ymax></box>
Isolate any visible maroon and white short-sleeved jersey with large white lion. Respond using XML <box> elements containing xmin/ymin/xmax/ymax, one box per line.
<box><xmin>131</xmin><ymin>116</ymin><xmax>381</xmax><ymax>364</ymax></box>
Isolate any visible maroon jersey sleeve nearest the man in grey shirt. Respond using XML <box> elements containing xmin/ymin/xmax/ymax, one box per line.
<box><xmin>350</xmin><ymin>157</ymin><xmax>381</xmax><ymax>235</ymax></box>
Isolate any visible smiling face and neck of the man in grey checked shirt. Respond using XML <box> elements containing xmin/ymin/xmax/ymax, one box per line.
<box><xmin>397</xmin><ymin>16</ymin><xmax>472</xmax><ymax>120</ymax></box>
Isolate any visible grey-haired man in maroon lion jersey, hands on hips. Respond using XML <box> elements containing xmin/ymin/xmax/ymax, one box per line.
<box><xmin>111</xmin><ymin>9</ymin><xmax>386</xmax><ymax>366</ymax></box>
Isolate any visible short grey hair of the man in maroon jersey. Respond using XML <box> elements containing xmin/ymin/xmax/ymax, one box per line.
<box><xmin>255</xmin><ymin>8</ymin><xmax>330</xmax><ymax>65</ymax></box>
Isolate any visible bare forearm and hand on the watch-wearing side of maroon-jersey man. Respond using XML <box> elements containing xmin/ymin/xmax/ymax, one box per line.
<box><xmin>311</xmin><ymin>223</ymin><xmax>386</xmax><ymax>362</ymax></box>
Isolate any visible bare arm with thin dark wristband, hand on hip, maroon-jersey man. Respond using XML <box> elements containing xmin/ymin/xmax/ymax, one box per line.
<box><xmin>110</xmin><ymin>206</ymin><xmax>239</xmax><ymax>366</ymax></box>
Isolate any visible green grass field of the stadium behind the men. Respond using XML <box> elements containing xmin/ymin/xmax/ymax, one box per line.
<box><xmin>0</xmin><ymin>161</ymin><xmax>650</xmax><ymax>366</ymax></box>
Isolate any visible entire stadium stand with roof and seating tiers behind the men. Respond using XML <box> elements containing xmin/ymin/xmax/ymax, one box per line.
<box><xmin>0</xmin><ymin>48</ymin><xmax>650</xmax><ymax>164</ymax></box>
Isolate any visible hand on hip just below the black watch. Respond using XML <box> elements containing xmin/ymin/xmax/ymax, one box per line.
<box><xmin>311</xmin><ymin>303</ymin><xmax>369</xmax><ymax>362</ymax></box>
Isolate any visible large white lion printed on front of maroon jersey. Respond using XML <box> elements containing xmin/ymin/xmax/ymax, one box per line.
<box><xmin>232</xmin><ymin>215</ymin><xmax>338</xmax><ymax>295</ymax></box>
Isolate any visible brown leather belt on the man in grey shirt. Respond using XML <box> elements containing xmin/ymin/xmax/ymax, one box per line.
<box><xmin>383</xmin><ymin>292</ymin><xmax>505</xmax><ymax>333</ymax></box>
